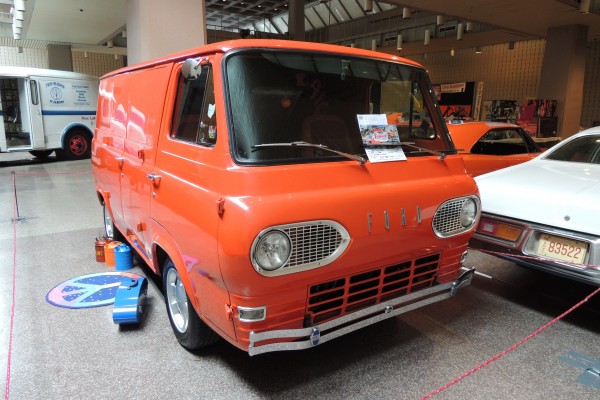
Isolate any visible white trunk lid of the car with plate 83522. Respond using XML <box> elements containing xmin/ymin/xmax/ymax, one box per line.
<box><xmin>475</xmin><ymin>158</ymin><xmax>600</xmax><ymax>235</ymax></box>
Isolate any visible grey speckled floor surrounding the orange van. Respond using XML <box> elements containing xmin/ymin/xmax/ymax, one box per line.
<box><xmin>0</xmin><ymin>153</ymin><xmax>600</xmax><ymax>400</ymax></box>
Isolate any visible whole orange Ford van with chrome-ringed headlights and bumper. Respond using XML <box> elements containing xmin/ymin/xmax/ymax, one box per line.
<box><xmin>92</xmin><ymin>40</ymin><xmax>480</xmax><ymax>355</ymax></box>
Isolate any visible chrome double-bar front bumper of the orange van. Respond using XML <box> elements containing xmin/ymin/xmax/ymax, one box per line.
<box><xmin>248</xmin><ymin>269</ymin><xmax>475</xmax><ymax>356</ymax></box>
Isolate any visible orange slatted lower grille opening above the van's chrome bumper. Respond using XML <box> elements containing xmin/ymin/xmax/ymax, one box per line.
<box><xmin>305</xmin><ymin>254</ymin><xmax>440</xmax><ymax>326</ymax></box>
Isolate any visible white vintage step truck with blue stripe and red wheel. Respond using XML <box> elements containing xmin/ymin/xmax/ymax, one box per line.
<box><xmin>0</xmin><ymin>66</ymin><xmax>98</xmax><ymax>159</ymax></box>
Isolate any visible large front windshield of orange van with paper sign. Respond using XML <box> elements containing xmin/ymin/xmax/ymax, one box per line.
<box><xmin>225</xmin><ymin>50</ymin><xmax>455</xmax><ymax>164</ymax></box>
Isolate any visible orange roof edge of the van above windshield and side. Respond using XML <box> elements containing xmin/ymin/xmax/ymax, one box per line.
<box><xmin>101</xmin><ymin>39</ymin><xmax>423</xmax><ymax>79</ymax></box>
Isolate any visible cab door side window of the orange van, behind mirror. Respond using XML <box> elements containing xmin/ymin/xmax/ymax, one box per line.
<box><xmin>171</xmin><ymin>66</ymin><xmax>217</xmax><ymax>146</ymax></box>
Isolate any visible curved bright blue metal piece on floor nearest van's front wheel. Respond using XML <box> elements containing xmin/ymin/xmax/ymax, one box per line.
<box><xmin>113</xmin><ymin>278</ymin><xmax>148</xmax><ymax>325</ymax></box>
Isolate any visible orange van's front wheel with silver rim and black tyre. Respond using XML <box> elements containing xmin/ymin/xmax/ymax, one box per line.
<box><xmin>163</xmin><ymin>258</ymin><xmax>218</xmax><ymax>350</ymax></box>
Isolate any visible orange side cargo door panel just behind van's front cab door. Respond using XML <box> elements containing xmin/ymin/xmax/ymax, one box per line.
<box><xmin>121</xmin><ymin>64</ymin><xmax>172</xmax><ymax>259</ymax></box>
